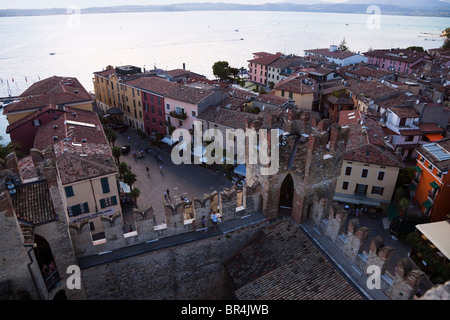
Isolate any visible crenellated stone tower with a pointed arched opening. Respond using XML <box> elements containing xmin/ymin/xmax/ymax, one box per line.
<box><xmin>246</xmin><ymin>109</ymin><xmax>349</xmax><ymax>224</ymax></box>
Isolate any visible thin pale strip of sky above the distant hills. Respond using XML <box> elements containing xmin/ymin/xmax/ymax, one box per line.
<box><xmin>0</xmin><ymin>0</ymin><xmax>347</xmax><ymax>9</ymax></box>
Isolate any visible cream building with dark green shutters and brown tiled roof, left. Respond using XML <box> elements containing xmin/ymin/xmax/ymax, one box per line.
<box><xmin>34</xmin><ymin>108</ymin><xmax>122</xmax><ymax>245</ymax></box>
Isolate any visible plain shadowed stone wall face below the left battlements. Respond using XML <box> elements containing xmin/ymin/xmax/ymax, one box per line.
<box><xmin>81</xmin><ymin>223</ymin><xmax>266</xmax><ymax>300</ymax></box>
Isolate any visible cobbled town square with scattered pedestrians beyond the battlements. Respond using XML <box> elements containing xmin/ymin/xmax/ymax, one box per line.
<box><xmin>115</xmin><ymin>128</ymin><xmax>233</xmax><ymax>225</ymax></box>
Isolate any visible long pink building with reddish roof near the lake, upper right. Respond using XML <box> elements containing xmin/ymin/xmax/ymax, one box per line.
<box><xmin>364</xmin><ymin>49</ymin><xmax>430</xmax><ymax>74</ymax></box>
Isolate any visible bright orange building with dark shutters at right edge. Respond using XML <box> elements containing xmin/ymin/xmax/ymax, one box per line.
<box><xmin>410</xmin><ymin>138</ymin><xmax>450</xmax><ymax>222</ymax></box>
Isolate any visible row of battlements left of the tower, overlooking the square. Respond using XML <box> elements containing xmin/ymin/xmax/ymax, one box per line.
<box><xmin>69</xmin><ymin>183</ymin><xmax>262</xmax><ymax>258</ymax></box>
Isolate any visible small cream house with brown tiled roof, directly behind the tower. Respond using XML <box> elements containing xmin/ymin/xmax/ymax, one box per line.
<box><xmin>274</xmin><ymin>76</ymin><xmax>317</xmax><ymax>110</ymax></box>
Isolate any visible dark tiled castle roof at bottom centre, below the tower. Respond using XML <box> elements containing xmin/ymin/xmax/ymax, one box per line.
<box><xmin>225</xmin><ymin>220</ymin><xmax>363</xmax><ymax>300</ymax></box>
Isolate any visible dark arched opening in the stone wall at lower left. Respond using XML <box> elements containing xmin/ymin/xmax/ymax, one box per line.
<box><xmin>33</xmin><ymin>234</ymin><xmax>61</xmax><ymax>291</ymax></box>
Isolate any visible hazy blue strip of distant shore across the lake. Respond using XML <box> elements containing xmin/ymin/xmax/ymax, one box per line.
<box><xmin>0</xmin><ymin>3</ymin><xmax>450</xmax><ymax>18</ymax></box>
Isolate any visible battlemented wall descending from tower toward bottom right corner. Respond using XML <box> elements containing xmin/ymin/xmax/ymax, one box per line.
<box><xmin>320</xmin><ymin>207</ymin><xmax>426</xmax><ymax>300</ymax></box>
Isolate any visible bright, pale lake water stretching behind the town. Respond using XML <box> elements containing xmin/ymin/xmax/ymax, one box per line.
<box><xmin>0</xmin><ymin>11</ymin><xmax>450</xmax><ymax>142</ymax></box>
